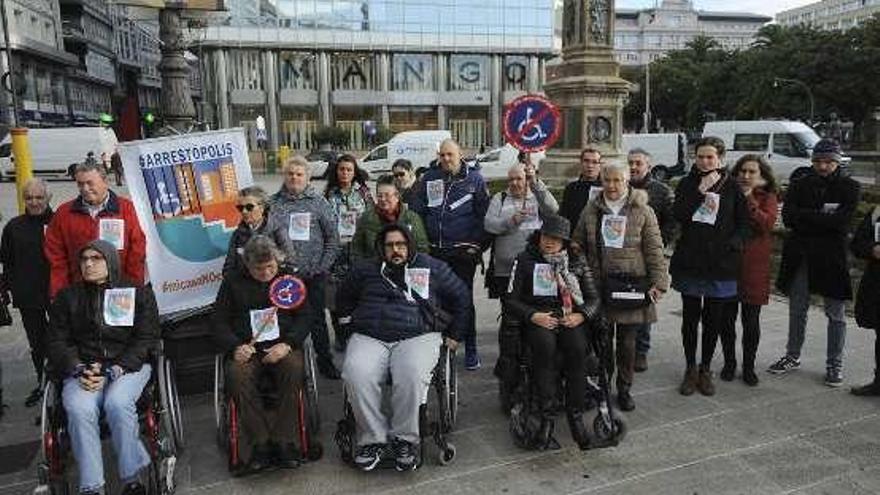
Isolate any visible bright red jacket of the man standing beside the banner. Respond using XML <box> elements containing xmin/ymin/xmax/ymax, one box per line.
<box><xmin>43</xmin><ymin>191</ymin><xmax>147</xmax><ymax>299</ymax></box>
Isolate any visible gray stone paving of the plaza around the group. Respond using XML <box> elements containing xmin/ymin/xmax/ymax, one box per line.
<box><xmin>0</xmin><ymin>178</ymin><xmax>880</xmax><ymax>495</ymax></box>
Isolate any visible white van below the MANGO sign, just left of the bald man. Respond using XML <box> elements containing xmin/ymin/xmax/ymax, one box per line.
<box><xmin>360</xmin><ymin>131</ymin><xmax>452</xmax><ymax>178</ymax></box>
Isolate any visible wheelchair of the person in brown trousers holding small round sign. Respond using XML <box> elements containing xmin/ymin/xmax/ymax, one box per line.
<box><xmin>214</xmin><ymin>337</ymin><xmax>324</xmax><ymax>473</ymax></box>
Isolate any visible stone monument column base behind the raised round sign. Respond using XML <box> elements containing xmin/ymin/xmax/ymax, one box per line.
<box><xmin>541</xmin><ymin>0</ymin><xmax>629</xmax><ymax>183</ymax></box>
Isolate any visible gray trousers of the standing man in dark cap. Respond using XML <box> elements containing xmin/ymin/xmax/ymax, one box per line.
<box><xmin>786</xmin><ymin>262</ymin><xmax>846</xmax><ymax>368</ymax></box>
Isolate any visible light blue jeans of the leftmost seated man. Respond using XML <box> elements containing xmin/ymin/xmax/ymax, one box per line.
<box><xmin>62</xmin><ymin>364</ymin><xmax>151</xmax><ymax>491</ymax></box>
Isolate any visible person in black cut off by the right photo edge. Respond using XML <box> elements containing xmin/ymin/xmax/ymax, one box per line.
<box><xmin>850</xmin><ymin>206</ymin><xmax>880</xmax><ymax>396</ymax></box>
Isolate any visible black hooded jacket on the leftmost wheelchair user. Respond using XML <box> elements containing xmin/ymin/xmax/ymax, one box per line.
<box><xmin>48</xmin><ymin>240</ymin><xmax>160</xmax><ymax>376</ymax></box>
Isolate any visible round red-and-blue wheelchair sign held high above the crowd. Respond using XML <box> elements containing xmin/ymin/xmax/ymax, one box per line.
<box><xmin>504</xmin><ymin>95</ymin><xmax>562</xmax><ymax>152</ymax></box>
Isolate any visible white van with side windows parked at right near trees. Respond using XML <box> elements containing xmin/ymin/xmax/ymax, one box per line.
<box><xmin>703</xmin><ymin>120</ymin><xmax>849</xmax><ymax>182</ymax></box>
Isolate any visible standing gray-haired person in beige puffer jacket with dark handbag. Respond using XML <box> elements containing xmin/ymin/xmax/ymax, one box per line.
<box><xmin>572</xmin><ymin>162</ymin><xmax>669</xmax><ymax>411</ymax></box>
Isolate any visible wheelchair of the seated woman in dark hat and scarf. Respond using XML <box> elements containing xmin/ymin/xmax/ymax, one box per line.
<box><xmin>494</xmin><ymin>312</ymin><xmax>627</xmax><ymax>449</ymax></box>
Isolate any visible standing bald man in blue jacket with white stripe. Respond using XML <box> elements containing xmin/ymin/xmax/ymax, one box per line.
<box><xmin>410</xmin><ymin>139</ymin><xmax>489</xmax><ymax>370</ymax></box>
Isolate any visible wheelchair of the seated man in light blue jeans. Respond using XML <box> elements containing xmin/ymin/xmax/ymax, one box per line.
<box><xmin>34</xmin><ymin>353</ymin><xmax>184</xmax><ymax>495</ymax></box>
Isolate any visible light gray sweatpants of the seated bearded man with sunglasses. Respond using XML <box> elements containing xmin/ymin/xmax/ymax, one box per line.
<box><xmin>342</xmin><ymin>333</ymin><xmax>442</xmax><ymax>446</ymax></box>
